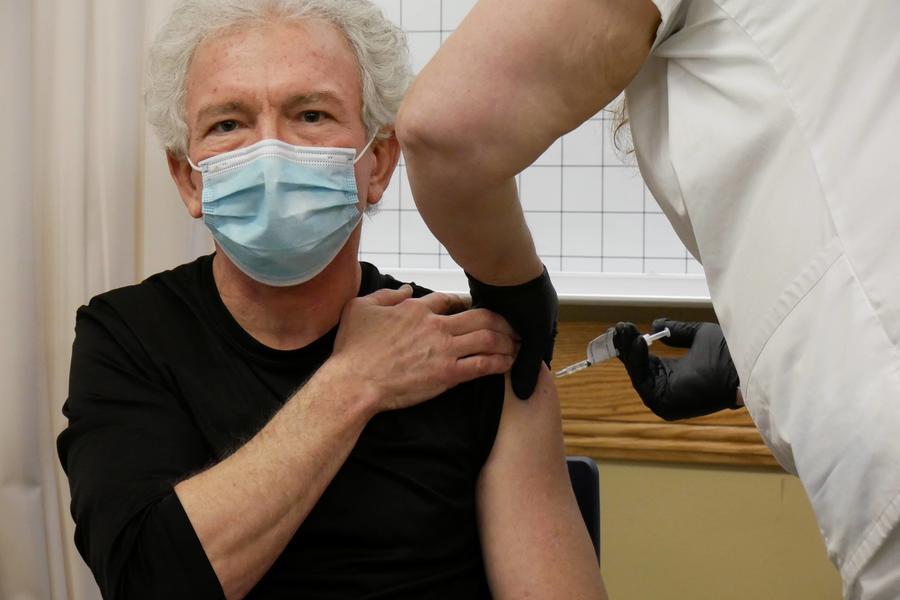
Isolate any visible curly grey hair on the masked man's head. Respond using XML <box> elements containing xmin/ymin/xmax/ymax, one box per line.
<box><xmin>144</xmin><ymin>0</ymin><xmax>412</xmax><ymax>158</ymax></box>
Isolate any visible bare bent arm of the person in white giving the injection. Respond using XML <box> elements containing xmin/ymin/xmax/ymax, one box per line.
<box><xmin>397</xmin><ymin>0</ymin><xmax>660</xmax><ymax>285</ymax></box>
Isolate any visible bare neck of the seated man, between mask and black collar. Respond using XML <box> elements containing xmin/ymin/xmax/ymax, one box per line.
<box><xmin>213</xmin><ymin>247</ymin><xmax>362</xmax><ymax>350</ymax></box>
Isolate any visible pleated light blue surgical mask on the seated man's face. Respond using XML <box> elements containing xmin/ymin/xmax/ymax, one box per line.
<box><xmin>188</xmin><ymin>137</ymin><xmax>375</xmax><ymax>287</ymax></box>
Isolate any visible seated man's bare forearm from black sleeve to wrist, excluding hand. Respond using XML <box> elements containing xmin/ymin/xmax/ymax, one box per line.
<box><xmin>175</xmin><ymin>363</ymin><xmax>372</xmax><ymax>599</ymax></box>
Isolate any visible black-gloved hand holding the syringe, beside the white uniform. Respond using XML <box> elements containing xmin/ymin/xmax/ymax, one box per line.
<box><xmin>613</xmin><ymin>319</ymin><xmax>739</xmax><ymax>421</ymax></box>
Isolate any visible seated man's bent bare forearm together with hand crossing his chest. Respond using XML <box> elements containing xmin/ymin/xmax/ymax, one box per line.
<box><xmin>175</xmin><ymin>287</ymin><xmax>515</xmax><ymax>598</ymax></box>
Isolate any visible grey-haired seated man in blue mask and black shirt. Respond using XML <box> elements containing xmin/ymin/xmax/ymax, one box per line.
<box><xmin>58</xmin><ymin>0</ymin><xmax>604</xmax><ymax>599</ymax></box>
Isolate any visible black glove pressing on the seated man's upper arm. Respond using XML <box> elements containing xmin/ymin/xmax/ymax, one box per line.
<box><xmin>466</xmin><ymin>267</ymin><xmax>559</xmax><ymax>400</ymax></box>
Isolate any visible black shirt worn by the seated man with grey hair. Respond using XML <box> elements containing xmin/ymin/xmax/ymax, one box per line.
<box><xmin>57</xmin><ymin>256</ymin><xmax>503</xmax><ymax>600</ymax></box>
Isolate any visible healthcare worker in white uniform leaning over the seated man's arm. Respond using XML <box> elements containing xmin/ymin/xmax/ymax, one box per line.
<box><xmin>397</xmin><ymin>0</ymin><xmax>900</xmax><ymax>600</ymax></box>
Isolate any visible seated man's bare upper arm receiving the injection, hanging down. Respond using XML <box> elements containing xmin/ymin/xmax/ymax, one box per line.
<box><xmin>478</xmin><ymin>368</ymin><xmax>606</xmax><ymax>600</ymax></box>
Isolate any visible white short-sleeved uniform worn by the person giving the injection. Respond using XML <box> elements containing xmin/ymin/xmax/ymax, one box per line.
<box><xmin>626</xmin><ymin>0</ymin><xmax>900</xmax><ymax>600</ymax></box>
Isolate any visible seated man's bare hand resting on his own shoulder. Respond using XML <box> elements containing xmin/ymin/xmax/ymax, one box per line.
<box><xmin>331</xmin><ymin>285</ymin><xmax>516</xmax><ymax>412</ymax></box>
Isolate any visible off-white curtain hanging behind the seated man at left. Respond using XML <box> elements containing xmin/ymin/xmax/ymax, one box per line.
<box><xmin>0</xmin><ymin>0</ymin><xmax>211</xmax><ymax>600</ymax></box>
